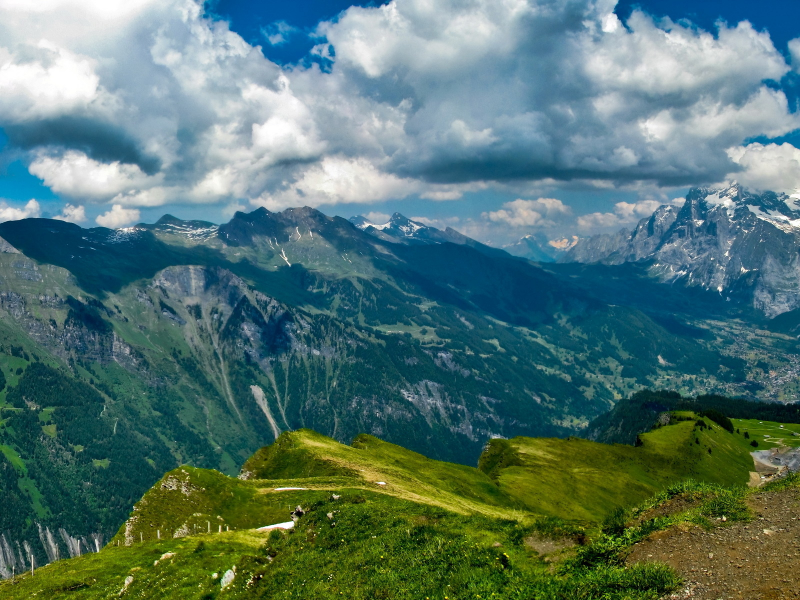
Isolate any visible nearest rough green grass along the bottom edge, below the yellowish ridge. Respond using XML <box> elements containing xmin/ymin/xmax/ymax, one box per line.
<box><xmin>0</xmin><ymin>489</ymin><xmax>679</xmax><ymax>600</ymax></box>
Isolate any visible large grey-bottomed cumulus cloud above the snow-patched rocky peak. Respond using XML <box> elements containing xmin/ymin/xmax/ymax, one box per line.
<box><xmin>323</xmin><ymin>0</ymin><xmax>798</xmax><ymax>184</ymax></box>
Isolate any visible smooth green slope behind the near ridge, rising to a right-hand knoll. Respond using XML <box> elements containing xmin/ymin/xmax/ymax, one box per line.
<box><xmin>482</xmin><ymin>419</ymin><xmax>752</xmax><ymax>520</ymax></box>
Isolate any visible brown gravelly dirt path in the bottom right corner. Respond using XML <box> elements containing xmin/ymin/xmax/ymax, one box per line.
<box><xmin>628</xmin><ymin>489</ymin><xmax>800</xmax><ymax>600</ymax></box>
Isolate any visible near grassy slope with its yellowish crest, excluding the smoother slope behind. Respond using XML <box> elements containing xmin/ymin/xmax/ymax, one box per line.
<box><xmin>0</xmin><ymin>431</ymin><xmax>688</xmax><ymax>600</ymax></box>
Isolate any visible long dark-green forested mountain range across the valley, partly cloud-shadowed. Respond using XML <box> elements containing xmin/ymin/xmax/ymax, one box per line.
<box><xmin>0</xmin><ymin>188</ymin><xmax>798</xmax><ymax>572</ymax></box>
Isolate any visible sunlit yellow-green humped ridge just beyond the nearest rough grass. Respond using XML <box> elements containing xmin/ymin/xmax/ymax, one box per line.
<box><xmin>111</xmin><ymin>430</ymin><xmax>526</xmax><ymax>545</ymax></box>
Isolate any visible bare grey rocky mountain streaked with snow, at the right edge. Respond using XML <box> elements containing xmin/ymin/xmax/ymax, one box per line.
<box><xmin>562</xmin><ymin>185</ymin><xmax>800</xmax><ymax>317</ymax></box>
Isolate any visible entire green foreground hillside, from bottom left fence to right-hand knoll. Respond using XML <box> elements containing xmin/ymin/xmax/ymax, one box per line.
<box><xmin>0</xmin><ymin>420</ymin><xmax>776</xmax><ymax>600</ymax></box>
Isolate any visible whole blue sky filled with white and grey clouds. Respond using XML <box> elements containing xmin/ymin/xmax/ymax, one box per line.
<box><xmin>0</xmin><ymin>0</ymin><xmax>800</xmax><ymax>245</ymax></box>
